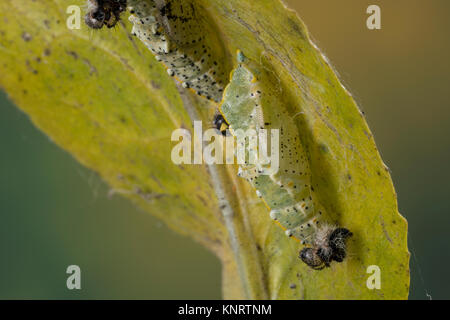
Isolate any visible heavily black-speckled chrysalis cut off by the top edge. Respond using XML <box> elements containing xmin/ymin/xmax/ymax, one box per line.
<box><xmin>128</xmin><ymin>0</ymin><xmax>228</xmax><ymax>102</ymax></box>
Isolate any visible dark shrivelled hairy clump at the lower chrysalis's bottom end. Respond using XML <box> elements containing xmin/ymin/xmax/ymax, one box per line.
<box><xmin>299</xmin><ymin>226</ymin><xmax>353</xmax><ymax>270</ymax></box>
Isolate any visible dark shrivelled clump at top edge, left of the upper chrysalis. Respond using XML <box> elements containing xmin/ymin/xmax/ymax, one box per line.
<box><xmin>84</xmin><ymin>0</ymin><xmax>127</xmax><ymax>29</ymax></box>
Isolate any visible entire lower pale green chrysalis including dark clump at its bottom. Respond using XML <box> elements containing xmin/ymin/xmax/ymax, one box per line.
<box><xmin>219</xmin><ymin>51</ymin><xmax>352</xmax><ymax>270</ymax></box>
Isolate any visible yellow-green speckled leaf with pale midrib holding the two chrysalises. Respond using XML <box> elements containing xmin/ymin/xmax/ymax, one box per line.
<box><xmin>0</xmin><ymin>0</ymin><xmax>409</xmax><ymax>299</ymax></box>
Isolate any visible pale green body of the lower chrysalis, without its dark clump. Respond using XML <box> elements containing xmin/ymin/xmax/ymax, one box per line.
<box><xmin>220</xmin><ymin>54</ymin><xmax>322</xmax><ymax>243</ymax></box>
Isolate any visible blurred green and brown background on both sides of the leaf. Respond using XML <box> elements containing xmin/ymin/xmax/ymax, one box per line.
<box><xmin>0</xmin><ymin>0</ymin><xmax>450</xmax><ymax>299</ymax></box>
